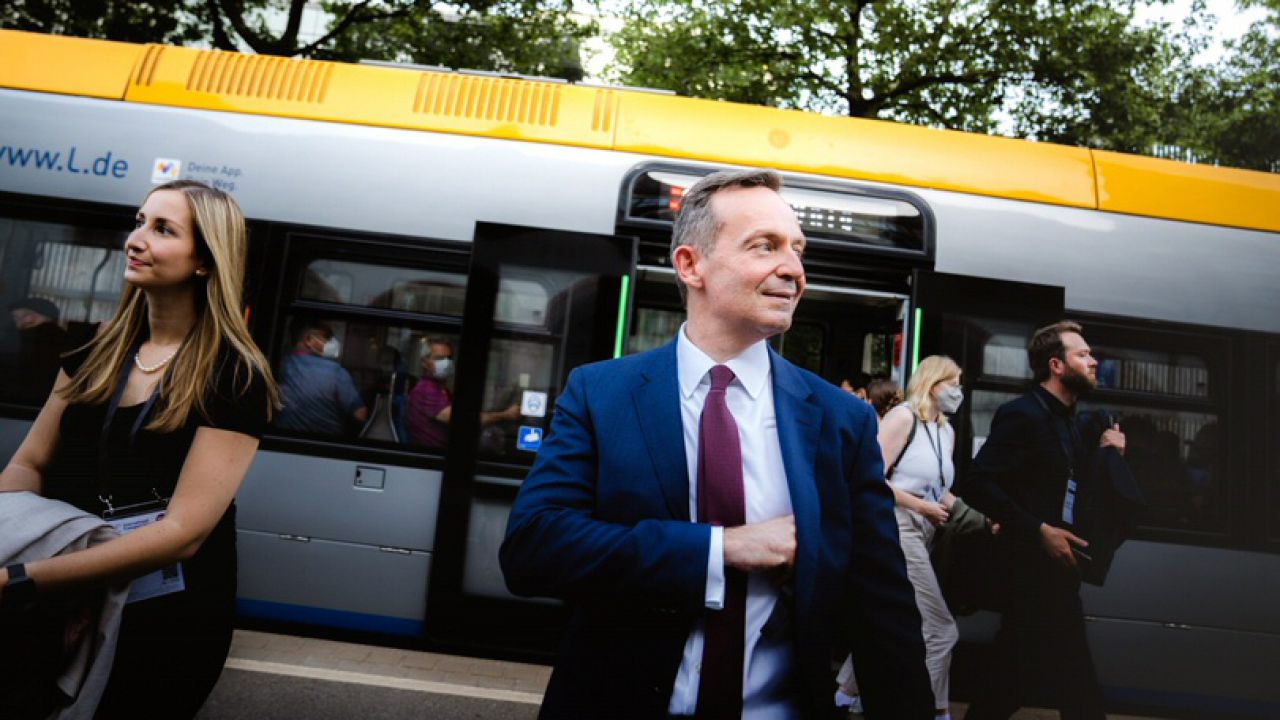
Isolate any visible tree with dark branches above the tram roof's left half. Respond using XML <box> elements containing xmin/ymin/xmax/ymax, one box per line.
<box><xmin>0</xmin><ymin>0</ymin><xmax>596</xmax><ymax>79</ymax></box>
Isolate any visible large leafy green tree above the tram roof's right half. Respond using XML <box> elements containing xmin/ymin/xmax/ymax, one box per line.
<box><xmin>613</xmin><ymin>0</ymin><xmax>1280</xmax><ymax>167</ymax></box>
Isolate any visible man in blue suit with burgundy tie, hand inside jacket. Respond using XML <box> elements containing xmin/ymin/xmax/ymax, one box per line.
<box><xmin>500</xmin><ymin>170</ymin><xmax>933</xmax><ymax>720</ymax></box>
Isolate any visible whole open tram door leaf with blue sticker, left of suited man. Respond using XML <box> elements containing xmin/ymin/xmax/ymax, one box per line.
<box><xmin>426</xmin><ymin>223</ymin><xmax>636</xmax><ymax>650</ymax></box>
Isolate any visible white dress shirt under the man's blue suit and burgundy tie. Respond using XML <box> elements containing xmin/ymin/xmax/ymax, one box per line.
<box><xmin>667</xmin><ymin>325</ymin><xmax>800</xmax><ymax>720</ymax></box>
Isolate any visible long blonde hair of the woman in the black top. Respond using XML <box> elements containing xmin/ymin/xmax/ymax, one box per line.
<box><xmin>63</xmin><ymin>181</ymin><xmax>280</xmax><ymax>432</ymax></box>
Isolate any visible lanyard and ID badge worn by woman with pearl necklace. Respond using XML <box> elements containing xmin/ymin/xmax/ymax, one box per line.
<box><xmin>97</xmin><ymin>351</ymin><xmax>187</xmax><ymax>603</ymax></box>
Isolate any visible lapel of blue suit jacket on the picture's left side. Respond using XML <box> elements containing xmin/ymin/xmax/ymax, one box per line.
<box><xmin>631</xmin><ymin>341</ymin><xmax>689</xmax><ymax>520</ymax></box>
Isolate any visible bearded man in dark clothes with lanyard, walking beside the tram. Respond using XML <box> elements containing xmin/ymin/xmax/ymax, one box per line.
<box><xmin>956</xmin><ymin>320</ymin><xmax>1125</xmax><ymax>720</ymax></box>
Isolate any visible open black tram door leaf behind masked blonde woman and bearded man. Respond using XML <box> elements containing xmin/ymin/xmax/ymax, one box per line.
<box><xmin>909</xmin><ymin>270</ymin><xmax>1065</xmax><ymax>473</ymax></box>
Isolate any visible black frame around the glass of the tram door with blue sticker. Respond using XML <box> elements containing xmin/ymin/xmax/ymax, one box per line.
<box><xmin>426</xmin><ymin>222</ymin><xmax>637</xmax><ymax>656</ymax></box>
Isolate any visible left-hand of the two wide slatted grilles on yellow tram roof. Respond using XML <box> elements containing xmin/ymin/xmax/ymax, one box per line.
<box><xmin>170</xmin><ymin>50</ymin><xmax>333</xmax><ymax>102</ymax></box>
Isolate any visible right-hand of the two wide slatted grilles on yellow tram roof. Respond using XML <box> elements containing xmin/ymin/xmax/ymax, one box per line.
<box><xmin>413</xmin><ymin>73</ymin><xmax>562</xmax><ymax>127</ymax></box>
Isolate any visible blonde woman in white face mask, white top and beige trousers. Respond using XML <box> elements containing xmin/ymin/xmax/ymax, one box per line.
<box><xmin>836</xmin><ymin>355</ymin><xmax>964</xmax><ymax>720</ymax></box>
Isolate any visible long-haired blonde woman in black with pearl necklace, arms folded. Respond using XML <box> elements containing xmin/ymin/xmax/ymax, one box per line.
<box><xmin>0</xmin><ymin>181</ymin><xmax>278</xmax><ymax>717</ymax></box>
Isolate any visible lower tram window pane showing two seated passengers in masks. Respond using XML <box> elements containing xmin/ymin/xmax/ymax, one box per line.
<box><xmin>274</xmin><ymin>314</ymin><xmax>458</xmax><ymax>452</ymax></box>
